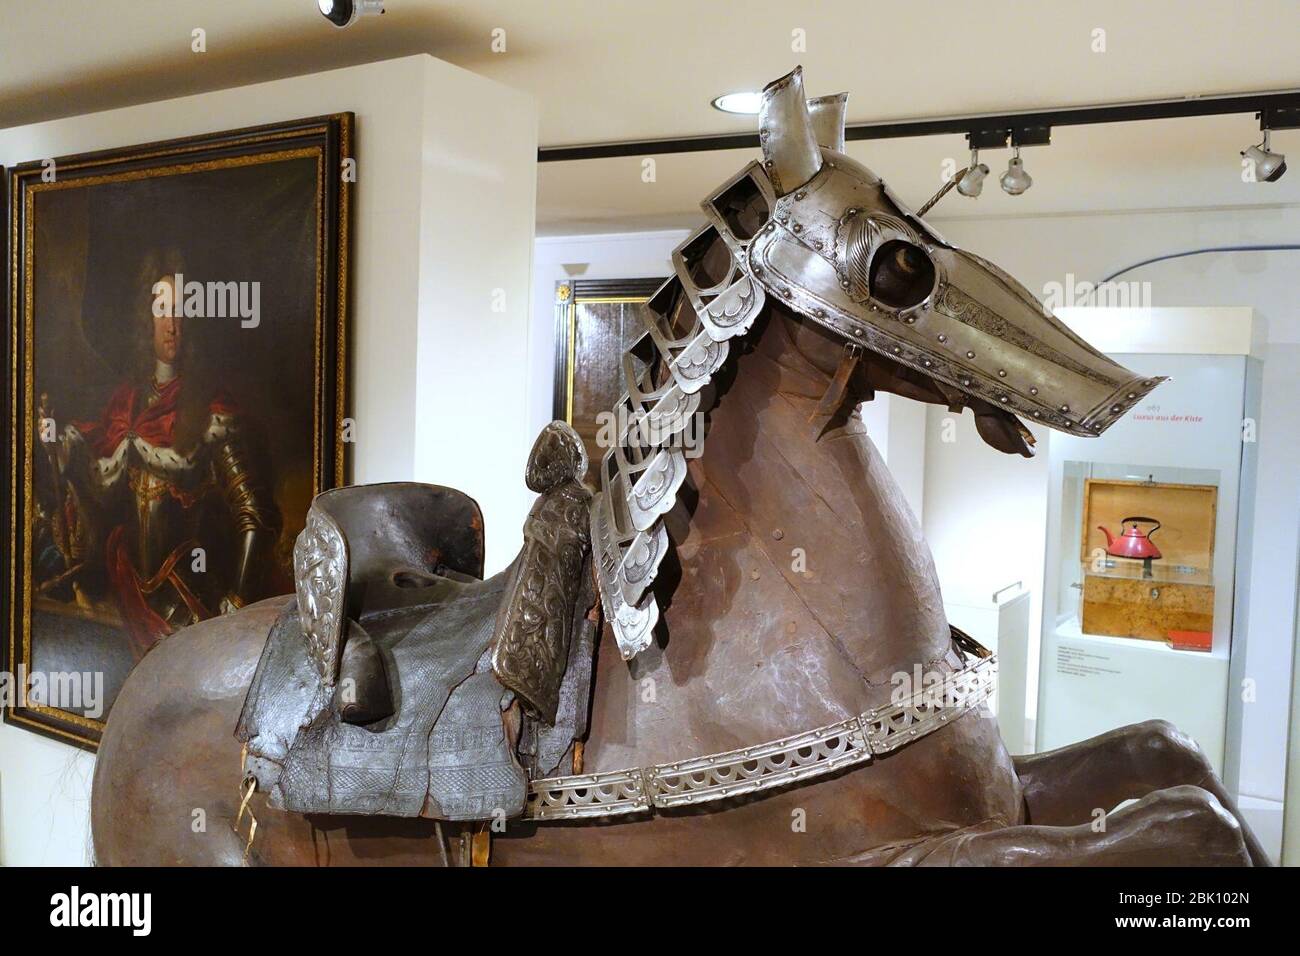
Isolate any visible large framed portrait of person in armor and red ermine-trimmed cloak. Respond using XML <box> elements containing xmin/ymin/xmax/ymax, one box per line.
<box><xmin>0</xmin><ymin>113</ymin><xmax>355</xmax><ymax>749</ymax></box>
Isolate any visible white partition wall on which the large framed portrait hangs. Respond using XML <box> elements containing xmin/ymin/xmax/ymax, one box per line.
<box><xmin>0</xmin><ymin>56</ymin><xmax>537</xmax><ymax>865</ymax></box>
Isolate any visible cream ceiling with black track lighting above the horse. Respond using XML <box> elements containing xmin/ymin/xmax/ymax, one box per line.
<box><xmin>0</xmin><ymin>0</ymin><xmax>1300</xmax><ymax>233</ymax></box>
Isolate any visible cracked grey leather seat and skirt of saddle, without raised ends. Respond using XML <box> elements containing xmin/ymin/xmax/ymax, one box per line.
<box><xmin>241</xmin><ymin>572</ymin><xmax>528</xmax><ymax>819</ymax></box>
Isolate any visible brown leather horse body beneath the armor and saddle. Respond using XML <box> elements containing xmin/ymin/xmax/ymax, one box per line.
<box><xmin>92</xmin><ymin>67</ymin><xmax>1266</xmax><ymax>865</ymax></box>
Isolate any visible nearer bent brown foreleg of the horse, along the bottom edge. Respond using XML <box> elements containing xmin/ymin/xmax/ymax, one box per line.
<box><xmin>892</xmin><ymin>786</ymin><xmax>1251</xmax><ymax>866</ymax></box>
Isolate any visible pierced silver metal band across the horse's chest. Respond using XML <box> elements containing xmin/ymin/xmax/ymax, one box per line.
<box><xmin>524</xmin><ymin>657</ymin><xmax>997</xmax><ymax>821</ymax></box>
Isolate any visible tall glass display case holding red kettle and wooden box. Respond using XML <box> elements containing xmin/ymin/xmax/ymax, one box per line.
<box><xmin>1035</xmin><ymin>310</ymin><xmax>1260</xmax><ymax>773</ymax></box>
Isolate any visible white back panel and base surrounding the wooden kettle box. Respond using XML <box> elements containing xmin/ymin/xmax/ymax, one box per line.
<box><xmin>1035</xmin><ymin>308</ymin><xmax>1261</xmax><ymax>774</ymax></box>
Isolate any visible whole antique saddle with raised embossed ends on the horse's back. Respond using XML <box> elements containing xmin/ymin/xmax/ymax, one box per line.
<box><xmin>235</xmin><ymin>421</ymin><xmax>598</xmax><ymax>821</ymax></box>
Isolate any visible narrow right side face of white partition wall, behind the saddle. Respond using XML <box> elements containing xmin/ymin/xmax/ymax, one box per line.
<box><xmin>416</xmin><ymin>57</ymin><xmax>537</xmax><ymax>574</ymax></box>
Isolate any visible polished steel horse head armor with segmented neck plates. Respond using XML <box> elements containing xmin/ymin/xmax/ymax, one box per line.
<box><xmin>592</xmin><ymin>69</ymin><xmax>1162</xmax><ymax>657</ymax></box>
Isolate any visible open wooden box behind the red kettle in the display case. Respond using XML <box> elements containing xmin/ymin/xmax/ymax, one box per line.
<box><xmin>1079</xmin><ymin>479</ymin><xmax>1218</xmax><ymax>641</ymax></box>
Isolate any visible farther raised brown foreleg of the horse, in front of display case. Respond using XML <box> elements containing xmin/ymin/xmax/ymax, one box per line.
<box><xmin>1013</xmin><ymin>721</ymin><xmax>1271</xmax><ymax>866</ymax></box>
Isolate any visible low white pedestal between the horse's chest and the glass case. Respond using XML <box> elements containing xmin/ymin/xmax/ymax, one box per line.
<box><xmin>944</xmin><ymin>585</ymin><xmax>1034</xmax><ymax>754</ymax></box>
